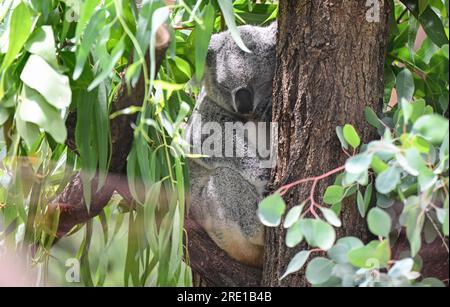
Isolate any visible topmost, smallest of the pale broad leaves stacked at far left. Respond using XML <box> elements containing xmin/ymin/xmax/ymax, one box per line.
<box><xmin>25</xmin><ymin>26</ymin><xmax>58</xmax><ymax>68</ymax></box>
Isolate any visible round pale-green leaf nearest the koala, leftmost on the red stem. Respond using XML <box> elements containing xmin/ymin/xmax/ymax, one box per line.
<box><xmin>258</xmin><ymin>193</ymin><xmax>286</xmax><ymax>227</ymax></box>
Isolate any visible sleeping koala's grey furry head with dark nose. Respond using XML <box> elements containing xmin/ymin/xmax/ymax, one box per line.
<box><xmin>204</xmin><ymin>23</ymin><xmax>277</xmax><ymax>118</ymax></box>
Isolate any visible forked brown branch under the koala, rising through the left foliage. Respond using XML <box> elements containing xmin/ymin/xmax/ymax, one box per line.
<box><xmin>50</xmin><ymin>26</ymin><xmax>262</xmax><ymax>286</ymax></box>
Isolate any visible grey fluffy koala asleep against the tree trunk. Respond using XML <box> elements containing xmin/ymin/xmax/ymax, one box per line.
<box><xmin>186</xmin><ymin>23</ymin><xmax>277</xmax><ymax>266</ymax></box>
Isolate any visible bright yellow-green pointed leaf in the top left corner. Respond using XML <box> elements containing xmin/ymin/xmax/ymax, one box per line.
<box><xmin>1</xmin><ymin>1</ymin><xmax>33</xmax><ymax>70</ymax></box>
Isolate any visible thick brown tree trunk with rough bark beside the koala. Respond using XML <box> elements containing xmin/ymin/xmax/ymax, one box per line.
<box><xmin>263</xmin><ymin>0</ymin><xmax>389</xmax><ymax>286</ymax></box>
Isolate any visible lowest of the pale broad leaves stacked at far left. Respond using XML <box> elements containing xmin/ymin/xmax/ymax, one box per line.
<box><xmin>17</xmin><ymin>86</ymin><xmax>67</xmax><ymax>144</ymax></box>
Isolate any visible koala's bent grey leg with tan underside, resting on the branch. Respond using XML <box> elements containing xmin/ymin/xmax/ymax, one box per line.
<box><xmin>190</xmin><ymin>164</ymin><xmax>264</xmax><ymax>266</ymax></box>
